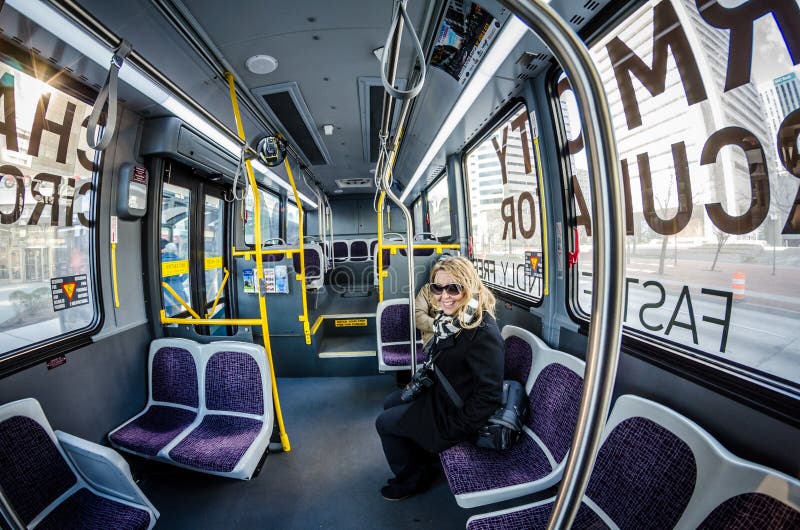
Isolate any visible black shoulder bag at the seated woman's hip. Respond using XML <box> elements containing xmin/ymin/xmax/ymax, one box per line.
<box><xmin>434</xmin><ymin>365</ymin><xmax>528</xmax><ymax>451</ymax></box>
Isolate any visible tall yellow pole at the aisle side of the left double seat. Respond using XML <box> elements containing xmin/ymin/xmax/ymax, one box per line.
<box><xmin>225</xmin><ymin>72</ymin><xmax>291</xmax><ymax>452</ymax></box>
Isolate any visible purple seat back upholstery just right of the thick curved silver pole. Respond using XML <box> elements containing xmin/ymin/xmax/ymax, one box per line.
<box><xmin>586</xmin><ymin>417</ymin><xmax>697</xmax><ymax>530</ymax></box>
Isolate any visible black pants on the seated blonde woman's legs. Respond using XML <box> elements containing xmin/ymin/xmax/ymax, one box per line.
<box><xmin>375</xmin><ymin>390</ymin><xmax>435</xmax><ymax>484</ymax></box>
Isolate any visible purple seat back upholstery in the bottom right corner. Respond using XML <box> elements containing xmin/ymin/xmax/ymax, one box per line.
<box><xmin>698</xmin><ymin>493</ymin><xmax>800</xmax><ymax>530</ymax></box>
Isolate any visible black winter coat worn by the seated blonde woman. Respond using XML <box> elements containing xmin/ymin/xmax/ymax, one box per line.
<box><xmin>400</xmin><ymin>314</ymin><xmax>505</xmax><ymax>453</ymax></box>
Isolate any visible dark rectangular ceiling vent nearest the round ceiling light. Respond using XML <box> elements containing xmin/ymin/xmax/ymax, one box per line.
<box><xmin>253</xmin><ymin>82</ymin><xmax>331</xmax><ymax>166</ymax></box>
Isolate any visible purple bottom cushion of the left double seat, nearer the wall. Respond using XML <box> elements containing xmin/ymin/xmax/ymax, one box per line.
<box><xmin>109</xmin><ymin>405</ymin><xmax>197</xmax><ymax>456</ymax></box>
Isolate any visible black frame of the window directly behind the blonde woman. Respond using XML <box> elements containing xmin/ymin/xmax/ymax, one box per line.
<box><xmin>460</xmin><ymin>97</ymin><xmax>546</xmax><ymax>309</ymax></box>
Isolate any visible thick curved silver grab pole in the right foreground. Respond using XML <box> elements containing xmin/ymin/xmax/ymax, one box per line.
<box><xmin>500</xmin><ymin>0</ymin><xmax>625</xmax><ymax>530</ymax></box>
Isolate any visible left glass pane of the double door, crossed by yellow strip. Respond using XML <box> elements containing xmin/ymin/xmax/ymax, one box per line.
<box><xmin>161</xmin><ymin>183</ymin><xmax>192</xmax><ymax>316</ymax></box>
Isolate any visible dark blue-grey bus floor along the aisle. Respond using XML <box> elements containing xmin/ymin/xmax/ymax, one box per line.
<box><xmin>125</xmin><ymin>374</ymin><xmax>468</xmax><ymax>530</ymax></box>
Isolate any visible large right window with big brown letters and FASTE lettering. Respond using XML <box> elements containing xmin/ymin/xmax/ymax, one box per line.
<box><xmin>558</xmin><ymin>1</ymin><xmax>800</xmax><ymax>384</ymax></box>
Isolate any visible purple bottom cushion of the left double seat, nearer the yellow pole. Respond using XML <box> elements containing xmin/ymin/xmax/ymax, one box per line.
<box><xmin>169</xmin><ymin>414</ymin><xmax>263</xmax><ymax>473</ymax></box>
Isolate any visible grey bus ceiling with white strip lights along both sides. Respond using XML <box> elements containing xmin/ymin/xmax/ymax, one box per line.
<box><xmin>2</xmin><ymin>0</ymin><xmax>608</xmax><ymax>206</ymax></box>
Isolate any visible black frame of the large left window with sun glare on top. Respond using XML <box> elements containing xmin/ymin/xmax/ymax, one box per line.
<box><xmin>0</xmin><ymin>44</ymin><xmax>107</xmax><ymax>378</ymax></box>
